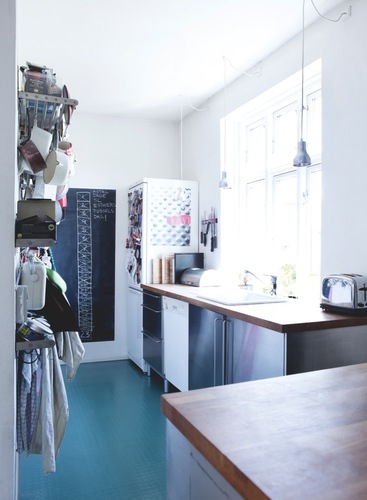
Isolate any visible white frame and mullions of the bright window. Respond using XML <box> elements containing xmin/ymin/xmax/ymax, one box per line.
<box><xmin>221</xmin><ymin>60</ymin><xmax>321</xmax><ymax>297</ymax></box>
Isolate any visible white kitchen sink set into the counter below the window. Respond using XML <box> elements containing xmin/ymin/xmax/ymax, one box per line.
<box><xmin>197</xmin><ymin>287</ymin><xmax>287</xmax><ymax>306</ymax></box>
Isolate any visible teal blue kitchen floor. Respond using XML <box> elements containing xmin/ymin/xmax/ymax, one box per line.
<box><xmin>19</xmin><ymin>360</ymin><xmax>166</xmax><ymax>500</ymax></box>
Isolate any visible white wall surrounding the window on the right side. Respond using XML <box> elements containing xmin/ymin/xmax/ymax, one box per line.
<box><xmin>183</xmin><ymin>0</ymin><xmax>367</xmax><ymax>282</ymax></box>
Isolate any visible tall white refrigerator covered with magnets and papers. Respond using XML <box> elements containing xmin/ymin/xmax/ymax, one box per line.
<box><xmin>126</xmin><ymin>178</ymin><xmax>199</xmax><ymax>372</ymax></box>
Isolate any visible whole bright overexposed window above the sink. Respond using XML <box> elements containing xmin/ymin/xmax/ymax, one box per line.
<box><xmin>222</xmin><ymin>61</ymin><xmax>322</xmax><ymax>296</ymax></box>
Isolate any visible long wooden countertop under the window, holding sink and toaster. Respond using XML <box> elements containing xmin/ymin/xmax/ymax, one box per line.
<box><xmin>141</xmin><ymin>285</ymin><xmax>367</xmax><ymax>333</ymax></box>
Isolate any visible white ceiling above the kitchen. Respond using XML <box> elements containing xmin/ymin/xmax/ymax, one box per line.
<box><xmin>17</xmin><ymin>0</ymin><xmax>346</xmax><ymax>121</ymax></box>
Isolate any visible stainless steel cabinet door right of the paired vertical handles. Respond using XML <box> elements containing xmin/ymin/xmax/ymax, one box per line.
<box><xmin>225</xmin><ymin>318</ymin><xmax>285</xmax><ymax>384</ymax></box>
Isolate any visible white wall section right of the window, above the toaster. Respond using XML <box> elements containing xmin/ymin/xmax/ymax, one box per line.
<box><xmin>322</xmin><ymin>0</ymin><xmax>367</xmax><ymax>274</ymax></box>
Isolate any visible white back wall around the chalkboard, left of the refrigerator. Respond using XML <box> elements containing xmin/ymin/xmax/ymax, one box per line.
<box><xmin>69</xmin><ymin>114</ymin><xmax>180</xmax><ymax>361</ymax></box>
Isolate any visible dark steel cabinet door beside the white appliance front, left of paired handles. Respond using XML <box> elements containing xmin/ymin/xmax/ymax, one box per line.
<box><xmin>189</xmin><ymin>305</ymin><xmax>225</xmax><ymax>389</ymax></box>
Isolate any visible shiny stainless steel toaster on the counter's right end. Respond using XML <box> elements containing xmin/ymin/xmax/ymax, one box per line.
<box><xmin>320</xmin><ymin>274</ymin><xmax>367</xmax><ymax>316</ymax></box>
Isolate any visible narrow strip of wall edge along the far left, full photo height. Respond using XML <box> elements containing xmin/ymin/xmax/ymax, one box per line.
<box><xmin>0</xmin><ymin>0</ymin><xmax>17</xmax><ymax>500</ymax></box>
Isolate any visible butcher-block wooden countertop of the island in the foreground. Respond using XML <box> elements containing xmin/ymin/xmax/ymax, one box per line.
<box><xmin>161</xmin><ymin>364</ymin><xmax>367</xmax><ymax>500</ymax></box>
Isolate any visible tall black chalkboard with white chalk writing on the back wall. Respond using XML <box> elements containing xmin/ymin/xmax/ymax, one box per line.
<box><xmin>52</xmin><ymin>188</ymin><xmax>116</xmax><ymax>342</ymax></box>
